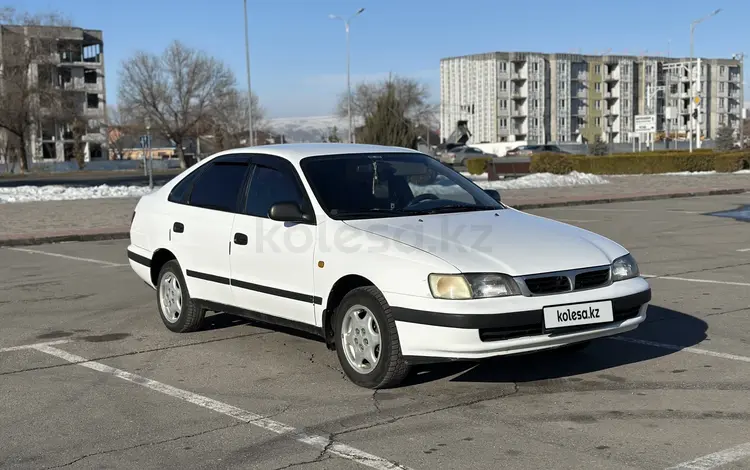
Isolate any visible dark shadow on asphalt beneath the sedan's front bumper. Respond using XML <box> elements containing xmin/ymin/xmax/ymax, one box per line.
<box><xmin>403</xmin><ymin>305</ymin><xmax>708</xmax><ymax>386</ymax></box>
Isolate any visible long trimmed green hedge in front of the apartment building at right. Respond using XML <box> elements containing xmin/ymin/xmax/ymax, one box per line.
<box><xmin>531</xmin><ymin>149</ymin><xmax>750</xmax><ymax>175</ymax></box>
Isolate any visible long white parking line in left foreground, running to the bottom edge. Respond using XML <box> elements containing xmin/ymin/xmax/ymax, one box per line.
<box><xmin>33</xmin><ymin>344</ymin><xmax>410</xmax><ymax>470</ymax></box>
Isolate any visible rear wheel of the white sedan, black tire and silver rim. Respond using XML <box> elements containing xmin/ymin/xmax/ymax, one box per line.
<box><xmin>156</xmin><ymin>260</ymin><xmax>206</xmax><ymax>333</ymax></box>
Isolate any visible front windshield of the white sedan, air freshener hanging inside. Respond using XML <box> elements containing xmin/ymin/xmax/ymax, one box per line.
<box><xmin>301</xmin><ymin>153</ymin><xmax>505</xmax><ymax>220</ymax></box>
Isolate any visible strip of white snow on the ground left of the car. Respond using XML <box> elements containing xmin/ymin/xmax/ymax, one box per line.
<box><xmin>0</xmin><ymin>184</ymin><xmax>159</xmax><ymax>204</ymax></box>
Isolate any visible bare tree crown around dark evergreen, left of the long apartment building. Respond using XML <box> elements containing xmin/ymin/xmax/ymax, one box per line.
<box><xmin>337</xmin><ymin>75</ymin><xmax>437</xmax><ymax>131</ymax></box>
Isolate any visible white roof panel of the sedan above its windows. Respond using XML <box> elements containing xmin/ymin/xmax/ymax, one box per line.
<box><xmin>212</xmin><ymin>143</ymin><xmax>421</xmax><ymax>162</ymax></box>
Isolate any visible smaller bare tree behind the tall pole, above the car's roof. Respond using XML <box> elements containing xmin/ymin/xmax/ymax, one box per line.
<box><xmin>211</xmin><ymin>89</ymin><xmax>268</xmax><ymax>150</ymax></box>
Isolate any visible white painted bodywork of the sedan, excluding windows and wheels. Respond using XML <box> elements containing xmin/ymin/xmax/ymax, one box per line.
<box><xmin>128</xmin><ymin>144</ymin><xmax>651</xmax><ymax>368</ymax></box>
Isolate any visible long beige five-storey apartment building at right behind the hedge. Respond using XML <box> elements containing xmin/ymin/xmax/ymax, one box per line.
<box><xmin>440</xmin><ymin>52</ymin><xmax>743</xmax><ymax>143</ymax></box>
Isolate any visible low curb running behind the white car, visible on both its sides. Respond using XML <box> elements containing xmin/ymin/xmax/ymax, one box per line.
<box><xmin>0</xmin><ymin>188</ymin><xmax>750</xmax><ymax>247</ymax></box>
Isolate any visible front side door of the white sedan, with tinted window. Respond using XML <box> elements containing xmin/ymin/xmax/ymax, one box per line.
<box><xmin>229</xmin><ymin>155</ymin><xmax>320</xmax><ymax>325</ymax></box>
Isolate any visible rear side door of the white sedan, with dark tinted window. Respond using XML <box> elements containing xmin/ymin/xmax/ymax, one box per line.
<box><xmin>169</xmin><ymin>155</ymin><xmax>249</xmax><ymax>305</ymax></box>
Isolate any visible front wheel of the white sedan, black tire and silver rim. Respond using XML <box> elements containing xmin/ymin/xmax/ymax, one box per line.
<box><xmin>334</xmin><ymin>286</ymin><xmax>410</xmax><ymax>389</ymax></box>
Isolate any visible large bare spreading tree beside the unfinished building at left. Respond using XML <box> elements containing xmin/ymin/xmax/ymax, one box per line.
<box><xmin>119</xmin><ymin>41</ymin><xmax>235</xmax><ymax>167</ymax></box>
